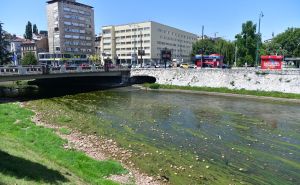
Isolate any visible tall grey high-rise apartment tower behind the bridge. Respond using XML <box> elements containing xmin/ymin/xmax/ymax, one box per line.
<box><xmin>47</xmin><ymin>0</ymin><xmax>95</xmax><ymax>54</ymax></box>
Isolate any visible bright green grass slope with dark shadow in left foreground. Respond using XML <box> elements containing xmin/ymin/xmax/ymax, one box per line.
<box><xmin>0</xmin><ymin>104</ymin><xmax>127</xmax><ymax>185</ymax></box>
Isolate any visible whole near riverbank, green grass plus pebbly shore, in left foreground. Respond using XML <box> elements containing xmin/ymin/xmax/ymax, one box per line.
<box><xmin>0</xmin><ymin>103</ymin><xmax>162</xmax><ymax>185</ymax></box>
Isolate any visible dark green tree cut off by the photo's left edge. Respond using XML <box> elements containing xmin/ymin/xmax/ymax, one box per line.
<box><xmin>0</xmin><ymin>23</ymin><xmax>11</xmax><ymax>65</ymax></box>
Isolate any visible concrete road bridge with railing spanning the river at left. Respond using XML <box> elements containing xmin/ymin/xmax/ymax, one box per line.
<box><xmin>0</xmin><ymin>66</ymin><xmax>130</xmax><ymax>82</ymax></box>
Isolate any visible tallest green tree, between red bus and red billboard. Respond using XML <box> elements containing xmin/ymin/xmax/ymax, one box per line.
<box><xmin>235</xmin><ymin>21</ymin><xmax>261</xmax><ymax>66</ymax></box>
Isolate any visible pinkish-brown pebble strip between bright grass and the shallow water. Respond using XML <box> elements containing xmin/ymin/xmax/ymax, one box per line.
<box><xmin>28</xmin><ymin>103</ymin><xmax>161</xmax><ymax>185</ymax></box>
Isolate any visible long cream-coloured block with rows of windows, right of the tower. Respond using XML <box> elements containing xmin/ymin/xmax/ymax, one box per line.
<box><xmin>102</xmin><ymin>21</ymin><xmax>197</xmax><ymax>63</ymax></box>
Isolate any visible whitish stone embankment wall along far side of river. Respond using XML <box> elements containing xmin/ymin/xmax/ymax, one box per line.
<box><xmin>131</xmin><ymin>68</ymin><xmax>300</xmax><ymax>93</ymax></box>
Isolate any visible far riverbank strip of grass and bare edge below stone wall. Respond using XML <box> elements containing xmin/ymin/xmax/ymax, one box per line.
<box><xmin>141</xmin><ymin>84</ymin><xmax>300</xmax><ymax>103</ymax></box>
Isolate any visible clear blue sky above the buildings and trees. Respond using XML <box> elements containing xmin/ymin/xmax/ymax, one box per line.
<box><xmin>0</xmin><ymin>0</ymin><xmax>300</xmax><ymax>40</ymax></box>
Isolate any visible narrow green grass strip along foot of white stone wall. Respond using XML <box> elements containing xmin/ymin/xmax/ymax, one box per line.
<box><xmin>144</xmin><ymin>84</ymin><xmax>300</xmax><ymax>99</ymax></box>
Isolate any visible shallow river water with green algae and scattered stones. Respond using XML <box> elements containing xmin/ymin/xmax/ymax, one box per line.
<box><xmin>43</xmin><ymin>88</ymin><xmax>300</xmax><ymax>185</ymax></box>
